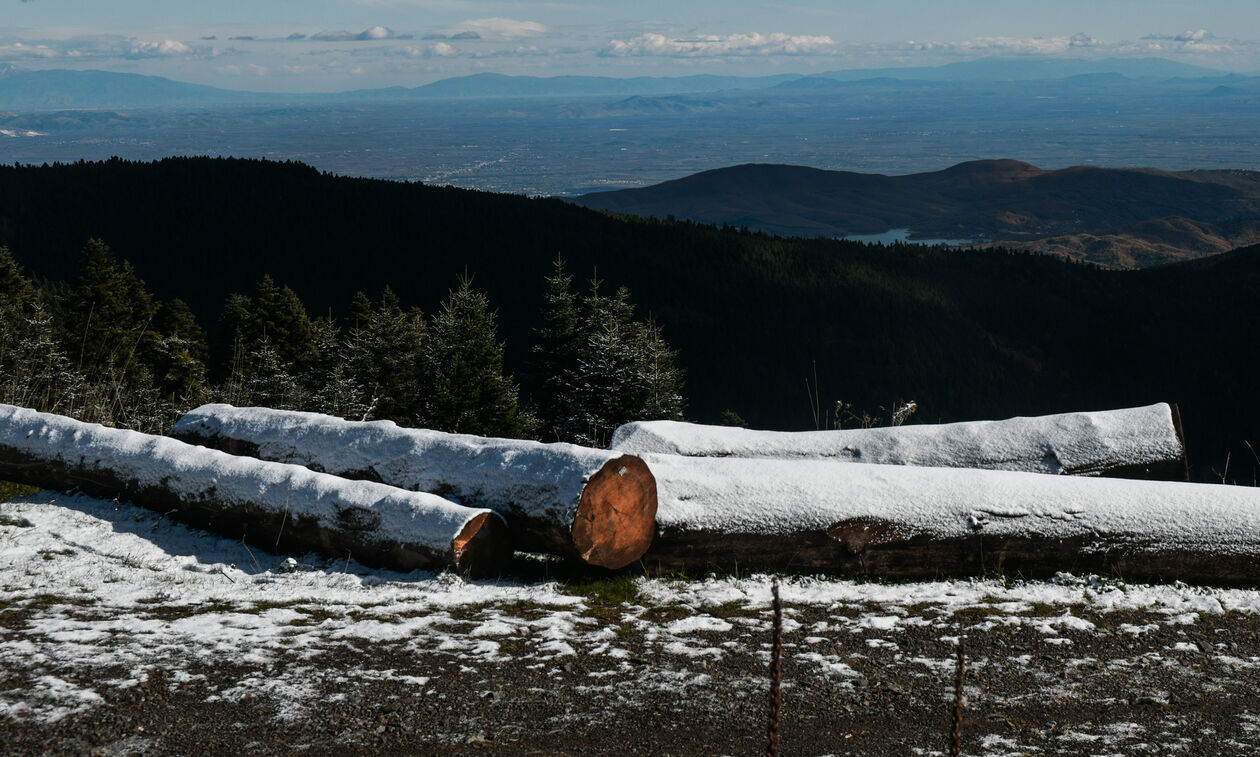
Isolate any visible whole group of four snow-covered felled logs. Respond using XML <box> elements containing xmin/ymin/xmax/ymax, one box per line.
<box><xmin>9</xmin><ymin>404</ymin><xmax>1260</xmax><ymax>584</ymax></box>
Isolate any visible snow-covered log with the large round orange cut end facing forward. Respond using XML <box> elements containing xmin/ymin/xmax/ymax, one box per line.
<box><xmin>171</xmin><ymin>404</ymin><xmax>656</xmax><ymax>568</ymax></box>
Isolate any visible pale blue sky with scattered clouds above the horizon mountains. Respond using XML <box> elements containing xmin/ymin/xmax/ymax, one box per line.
<box><xmin>0</xmin><ymin>0</ymin><xmax>1260</xmax><ymax>92</ymax></box>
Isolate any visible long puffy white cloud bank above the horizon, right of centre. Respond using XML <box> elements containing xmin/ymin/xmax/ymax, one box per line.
<box><xmin>601</xmin><ymin>31</ymin><xmax>840</xmax><ymax>58</ymax></box>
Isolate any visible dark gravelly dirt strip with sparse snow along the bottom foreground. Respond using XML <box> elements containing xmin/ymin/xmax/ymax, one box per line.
<box><xmin>0</xmin><ymin>605</ymin><xmax>1260</xmax><ymax>756</ymax></box>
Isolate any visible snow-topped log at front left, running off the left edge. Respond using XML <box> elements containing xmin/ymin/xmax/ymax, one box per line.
<box><xmin>0</xmin><ymin>404</ymin><xmax>512</xmax><ymax>574</ymax></box>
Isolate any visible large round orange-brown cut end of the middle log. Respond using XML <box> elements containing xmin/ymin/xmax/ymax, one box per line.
<box><xmin>572</xmin><ymin>455</ymin><xmax>656</xmax><ymax>569</ymax></box>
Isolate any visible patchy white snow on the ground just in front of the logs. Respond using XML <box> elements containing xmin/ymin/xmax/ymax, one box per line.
<box><xmin>7</xmin><ymin>492</ymin><xmax>1260</xmax><ymax>730</ymax></box>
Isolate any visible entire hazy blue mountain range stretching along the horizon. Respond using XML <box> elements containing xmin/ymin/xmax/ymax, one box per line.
<box><xmin>0</xmin><ymin>58</ymin><xmax>1250</xmax><ymax>112</ymax></box>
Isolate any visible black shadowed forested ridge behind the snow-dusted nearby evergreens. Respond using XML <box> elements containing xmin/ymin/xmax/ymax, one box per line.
<box><xmin>0</xmin><ymin>159</ymin><xmax>1260</xmax><ymax>482</ymax></box>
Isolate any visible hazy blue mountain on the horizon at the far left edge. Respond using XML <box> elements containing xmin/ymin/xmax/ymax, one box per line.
<box><xmin>0</xmin><ymin>67</ymin><xmax>260</xmax><ymax>111</ymax></box>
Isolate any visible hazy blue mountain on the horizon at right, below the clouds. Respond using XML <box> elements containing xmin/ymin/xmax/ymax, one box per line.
<box><xmin>822</xmin><ymin>58</ymin><xmax>1226</xmax><ymax>82</ymax></box>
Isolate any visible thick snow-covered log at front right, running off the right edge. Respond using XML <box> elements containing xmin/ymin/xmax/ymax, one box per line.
<box><xmin>644</xmin><ymin>455</ymin><xmax>1260</xmax><ymax>584</ymax></box>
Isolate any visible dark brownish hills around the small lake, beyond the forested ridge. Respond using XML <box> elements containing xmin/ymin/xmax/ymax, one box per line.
<box><xmin>575</xmin><ymin>160</ymin><xmax>1260</xmax><ymax>268</ymax></box>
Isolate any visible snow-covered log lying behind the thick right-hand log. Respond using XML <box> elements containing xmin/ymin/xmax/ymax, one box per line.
<box><xmin>612</xmin><ymin>403</ymin><xmax>1188</xmax><ymax>481</ymax></box>
